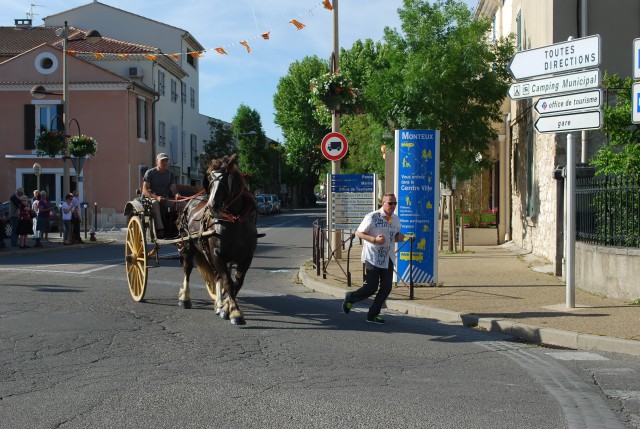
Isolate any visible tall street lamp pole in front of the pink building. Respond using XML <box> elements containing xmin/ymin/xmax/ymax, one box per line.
<box><xmin>31</xmin><ymin>21</ymin><xmax>102</xmax><ymax>198</ymax></box>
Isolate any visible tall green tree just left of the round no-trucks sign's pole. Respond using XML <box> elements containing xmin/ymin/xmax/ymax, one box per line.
<box><xmin>273</xmin><ymin>56</ymin><xmax>331</xmax><ymax>206</ymax></box>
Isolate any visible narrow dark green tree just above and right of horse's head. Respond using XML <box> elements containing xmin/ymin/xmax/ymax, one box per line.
<box><xmin>233</xmin><ymin>104</ymin><xmax>268</xmax><ymax>189</ymax></box>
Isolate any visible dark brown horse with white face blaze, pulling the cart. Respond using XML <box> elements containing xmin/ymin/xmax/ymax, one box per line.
<box><xmin>177</xmin><ymin>154</ymin><xmax>259</xmax><ymax>325</ymax></box>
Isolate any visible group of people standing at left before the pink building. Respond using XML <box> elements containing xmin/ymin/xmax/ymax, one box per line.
<box><xmin>0</xmin><ymin>188</ymin><xmax>82</xmax><ymax>249</ymax></box>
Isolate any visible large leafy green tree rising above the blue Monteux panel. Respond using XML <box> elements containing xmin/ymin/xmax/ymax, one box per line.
<box><xmin>363</xmin><ymin>0</ymin><xmax>514</xmax><ymax>185</ymax></box>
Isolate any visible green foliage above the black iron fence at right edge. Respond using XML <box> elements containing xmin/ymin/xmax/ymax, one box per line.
<box><xmin>591</xmin><ymin>73</ymin><xmax>640</xmax><ymax>180</ymax></box>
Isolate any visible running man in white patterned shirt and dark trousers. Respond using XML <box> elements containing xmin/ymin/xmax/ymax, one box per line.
<box><xmin>342</xmin><ymin>194</ymin><xmax>404</xmax><ymax>325</ymax></box>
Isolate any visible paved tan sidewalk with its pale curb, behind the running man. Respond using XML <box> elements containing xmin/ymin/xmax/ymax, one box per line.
<box><xmin>299</xmin><ymin>243</ymin><xmax>640</xmax><ymax>356</ymax></box>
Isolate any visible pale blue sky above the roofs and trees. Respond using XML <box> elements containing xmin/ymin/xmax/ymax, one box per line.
<box><xmin>0</xmin><ymin>0</ymin><xmax>477</xmax><ymax>143</ymax></box>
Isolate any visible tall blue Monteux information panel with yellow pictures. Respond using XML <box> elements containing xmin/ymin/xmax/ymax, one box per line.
<box><xmin>394</xmin><ymin>130</ymin><xmax>440</xmax><ymax>284</ymax></box>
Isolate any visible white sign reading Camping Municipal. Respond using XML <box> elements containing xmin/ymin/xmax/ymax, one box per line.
<box><xmin>509</xmin><ymin>69</ymin><xmax>600</xmax><ymax>100</ymax></box>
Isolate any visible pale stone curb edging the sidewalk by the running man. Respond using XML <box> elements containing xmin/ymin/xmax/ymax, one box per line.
<box><xmin>298</xmin><ymin>266</ymin><xmax>640</xmax><ymax>356</ymax></box>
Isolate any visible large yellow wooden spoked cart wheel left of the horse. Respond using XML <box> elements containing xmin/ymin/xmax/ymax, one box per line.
<box><xmin>124</xmin><ymin>216</ymin><xmax>148</xmax><ymax>302</ymax></box>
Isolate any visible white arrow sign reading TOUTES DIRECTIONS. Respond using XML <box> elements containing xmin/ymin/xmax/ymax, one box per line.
<box><xmin>509</xmin><ymin>34</ymin><xmax>600</xmax><ymax>79</ymax></box>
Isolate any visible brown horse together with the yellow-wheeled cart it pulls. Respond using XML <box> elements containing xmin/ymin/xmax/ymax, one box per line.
<box><xmin>124</xmin><ymin>155</ymin><xmax>258</xmax><ymax>325</ymax></box>
